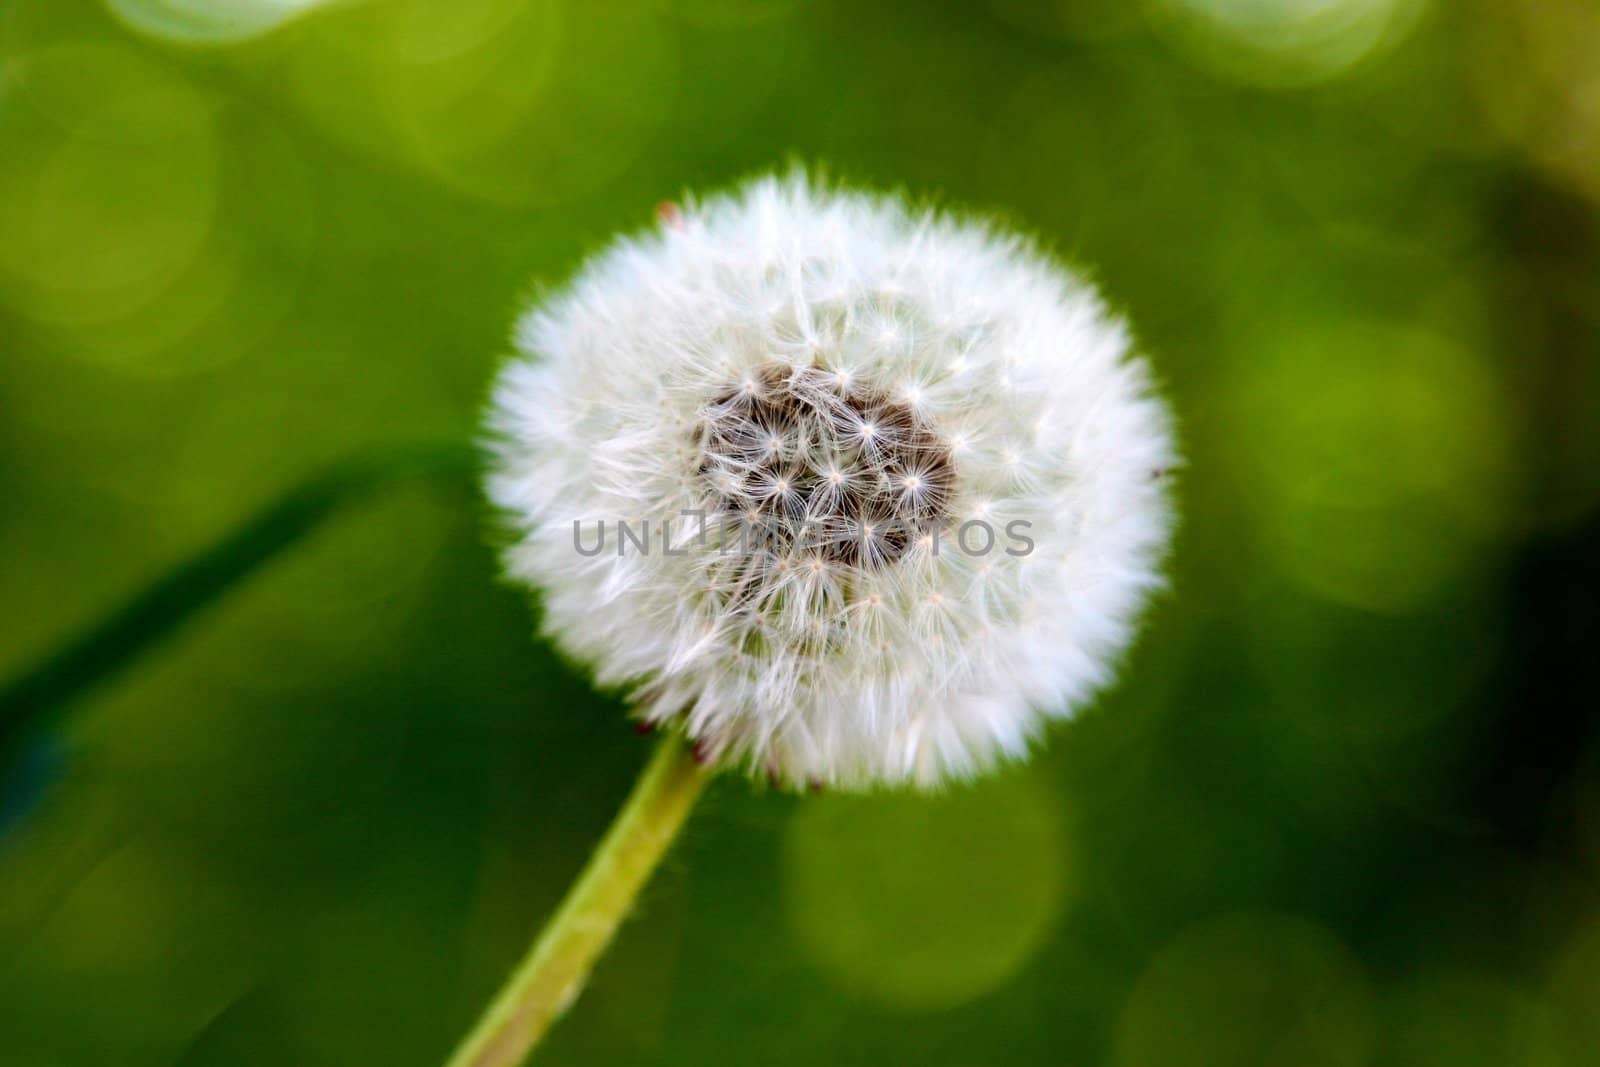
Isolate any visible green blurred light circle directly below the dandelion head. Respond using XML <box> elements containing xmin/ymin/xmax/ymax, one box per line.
<box><xmin>782</xmin><ymin>774</ymin><xmax>1067</xmax><ymax>1009</ymax></box>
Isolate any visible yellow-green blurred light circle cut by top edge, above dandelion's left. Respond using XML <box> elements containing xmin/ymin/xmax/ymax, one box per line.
<box><xmin>269</xmin><ymin>0</ymin><xmax>680</xmax><ymax>206</ymax></box>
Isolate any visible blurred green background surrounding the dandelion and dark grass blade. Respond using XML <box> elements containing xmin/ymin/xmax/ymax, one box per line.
<box><xmin>0</xmin><ymin>0</ymin><xmax>1600</xmax><ymax>1067</ymax></box>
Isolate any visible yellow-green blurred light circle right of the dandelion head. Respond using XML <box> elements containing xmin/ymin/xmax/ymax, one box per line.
<box><xmin>1226</xmin><ymin>320</ymin><xmax>1510</xmax><ymax>613</ymax></box>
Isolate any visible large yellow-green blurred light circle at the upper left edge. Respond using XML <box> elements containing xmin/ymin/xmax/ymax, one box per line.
<box><xmin>0</xmin><ymin>42</ymin><xmax>324</xmax><ymax>376</ymax></box>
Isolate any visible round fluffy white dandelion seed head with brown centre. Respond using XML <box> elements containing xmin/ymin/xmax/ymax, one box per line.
<box><xmin>490</xmin><ymin>176</ymin><xmax>1176</xmax><ymax>789</ymax></box>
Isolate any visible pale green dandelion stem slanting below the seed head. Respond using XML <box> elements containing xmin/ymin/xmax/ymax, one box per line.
<box><xmin>448</xmin><ymin>733</ymin><xmax>710</xmax><ymax>1067</ymax></box>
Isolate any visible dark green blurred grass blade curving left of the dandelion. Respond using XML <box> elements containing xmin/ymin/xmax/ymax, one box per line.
<box><xmin>0</xmin><ymin>443</ymin><xmax>475</xmax><ymax>774</ymax></box>
